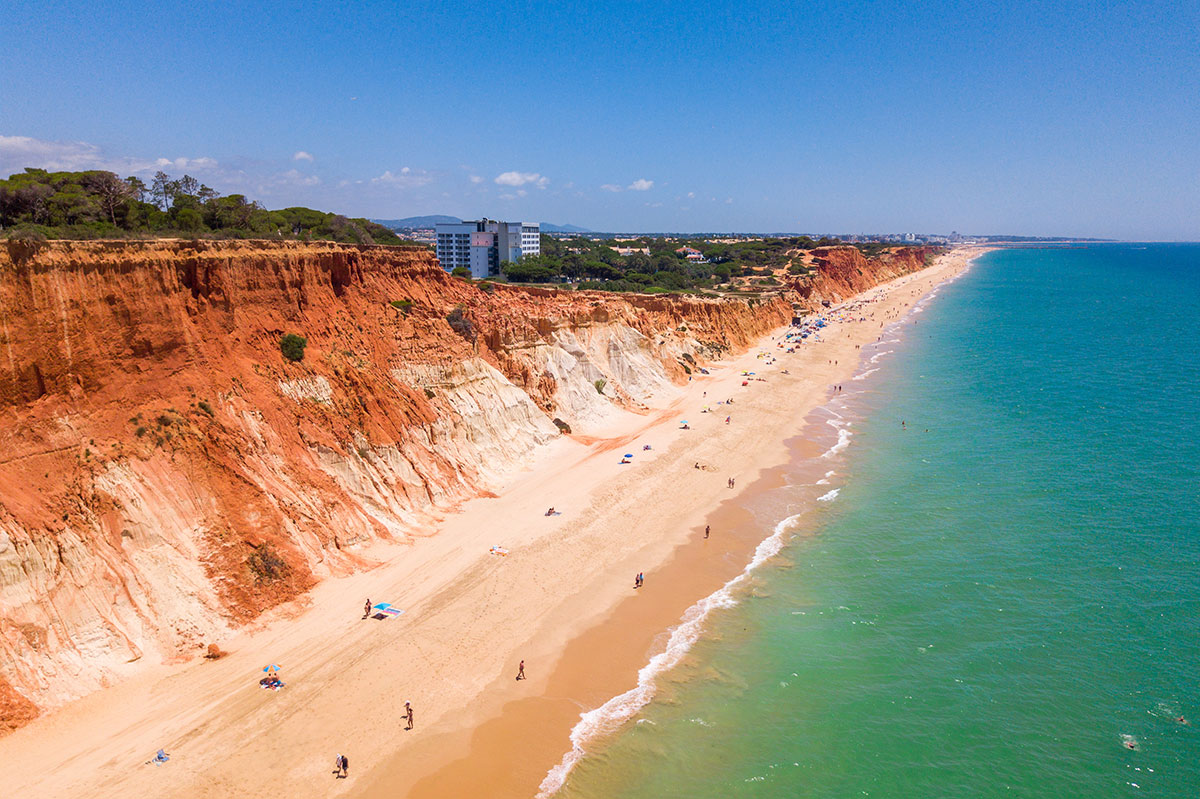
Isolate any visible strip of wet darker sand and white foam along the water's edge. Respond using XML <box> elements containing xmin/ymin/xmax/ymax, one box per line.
<box><xmin>354</xmin><ymin>248</ymin><xmax>990</xmax><ymax>799</ymax></box>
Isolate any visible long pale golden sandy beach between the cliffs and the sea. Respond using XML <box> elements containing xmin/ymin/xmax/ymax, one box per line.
<box><xmin>0</xmin><ymin>248</ymin><xmax>983</xmax><ymax>799</ymax></box>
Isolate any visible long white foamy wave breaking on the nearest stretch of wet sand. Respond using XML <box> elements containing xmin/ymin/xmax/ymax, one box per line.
<box><xmin>536</xmin><ymin>513</ymin><xmax>800</xmax><ymax>799</ymax></box>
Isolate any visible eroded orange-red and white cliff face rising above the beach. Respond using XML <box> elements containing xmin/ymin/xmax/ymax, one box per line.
<box><xmin>0</xmin><ymin>241</ymin><xmax>926</xmax><ymax>733</ymax></box>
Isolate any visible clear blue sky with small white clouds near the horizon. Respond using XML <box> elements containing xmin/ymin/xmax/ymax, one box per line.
<box><xmin>0</xmin><ymin>0</ymin><xmax>1200</xmax><ymax>240</ymax></box>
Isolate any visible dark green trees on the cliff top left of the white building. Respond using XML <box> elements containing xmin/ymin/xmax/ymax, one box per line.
<box><xmin>0</xmin><ymin>169</ymin><xmax>424</xmax><ymax>246</ymax></box>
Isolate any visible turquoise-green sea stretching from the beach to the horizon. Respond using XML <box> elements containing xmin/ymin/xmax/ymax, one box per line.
<box><xmin>559</xmin><ymin>245</ymin><xmax>1200</xmax><ymax>799</ymax></box>
